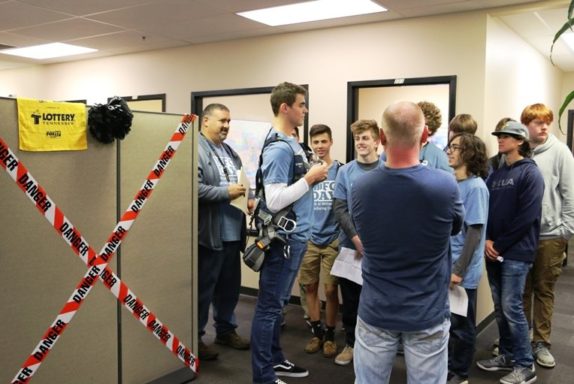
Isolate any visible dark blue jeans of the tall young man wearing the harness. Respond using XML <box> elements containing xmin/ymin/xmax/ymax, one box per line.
<box><xmin>251</xmin><ymin>240</ymin><xmax>307</xmax><ymax>384</ymax></box>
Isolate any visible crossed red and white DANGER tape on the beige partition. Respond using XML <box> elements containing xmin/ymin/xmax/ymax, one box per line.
<box><xmin>0</xmin><ymin>115</ymin><xmax>199</xmax><ymax>384</ymax></box>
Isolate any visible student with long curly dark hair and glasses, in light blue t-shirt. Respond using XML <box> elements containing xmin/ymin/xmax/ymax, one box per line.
<box><xmin>446</xmin><ymin>133</ymin><xmax>489</xmax><ymax>384</ymax></box>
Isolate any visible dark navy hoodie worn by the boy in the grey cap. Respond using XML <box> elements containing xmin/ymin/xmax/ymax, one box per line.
<box><xmin>486</xmin><ymin>158</ymin><xmax>544</xmax><ymax>263</ymax></box>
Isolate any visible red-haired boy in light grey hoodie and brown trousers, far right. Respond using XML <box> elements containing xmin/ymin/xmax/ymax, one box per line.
<box><xmin>520</xmin><ymin>104</ymin><xmax>574</xmax><ymax>368</ymax></box>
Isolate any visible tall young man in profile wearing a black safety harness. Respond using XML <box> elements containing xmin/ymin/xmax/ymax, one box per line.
<box><xmin>251</xmin><ymin>82</ymin><xmax>327</xmax><ymax>384</ymax></box>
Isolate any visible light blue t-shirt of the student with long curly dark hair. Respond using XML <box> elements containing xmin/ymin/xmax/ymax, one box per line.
<box><xmin>450</xmin><ymin>176</ymin><xmax>489</xmax><ymax>289</ymax></box>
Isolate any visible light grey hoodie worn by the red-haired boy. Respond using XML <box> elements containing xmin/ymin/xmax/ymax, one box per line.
<box><xmin>532</xmin><ymin>134</ymin><xmax>574</xmax><ymax>240</ymax></box>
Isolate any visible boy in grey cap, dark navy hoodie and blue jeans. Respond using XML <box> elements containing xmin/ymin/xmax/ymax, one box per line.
<box><xmin>477</xmin><ymin>121</ymin><xmax>544</xmax><ymax>384</ymax></box>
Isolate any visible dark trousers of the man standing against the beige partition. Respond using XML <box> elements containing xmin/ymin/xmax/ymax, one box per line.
<box><xmin>198</xmin><ymin>241</ymin><xmax>241</xmax><ymax>338</ymax></box>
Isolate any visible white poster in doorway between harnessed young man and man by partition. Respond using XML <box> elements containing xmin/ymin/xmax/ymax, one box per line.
<box><xmin>225</xmin><ymin>120</ymin><xmax>271</xmax><ymax>190</ymax></box>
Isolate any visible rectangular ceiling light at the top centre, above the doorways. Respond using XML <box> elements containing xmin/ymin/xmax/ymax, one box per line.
<box><xmin>237</xmin><ymin>0</ymin><xmax>386</xmax><ymax>27</ymax></box>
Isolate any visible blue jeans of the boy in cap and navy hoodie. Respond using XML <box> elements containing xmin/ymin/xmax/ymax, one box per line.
<box><xmin>486</xmin><ymin>259</ymin><xmax>534</xmax><ymax>367</ymax></box>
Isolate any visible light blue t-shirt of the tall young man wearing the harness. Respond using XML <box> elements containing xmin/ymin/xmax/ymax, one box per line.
<box><xmin>261</xmin><ymin>129</ymin><xmax>313</xmax><ymax>242</ymax></box>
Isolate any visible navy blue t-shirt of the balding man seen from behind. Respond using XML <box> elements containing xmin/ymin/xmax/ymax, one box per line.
<box><xmin>352</xmin><ymin>165</ymin><xmax>464</xmax><ymax>332</ymax></box>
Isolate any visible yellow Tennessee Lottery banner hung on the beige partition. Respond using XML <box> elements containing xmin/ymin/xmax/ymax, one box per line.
<box><xmin>17</xmin><ymin>98</ymin><xmax>88</xmax><ymax>151</ymax></box>
